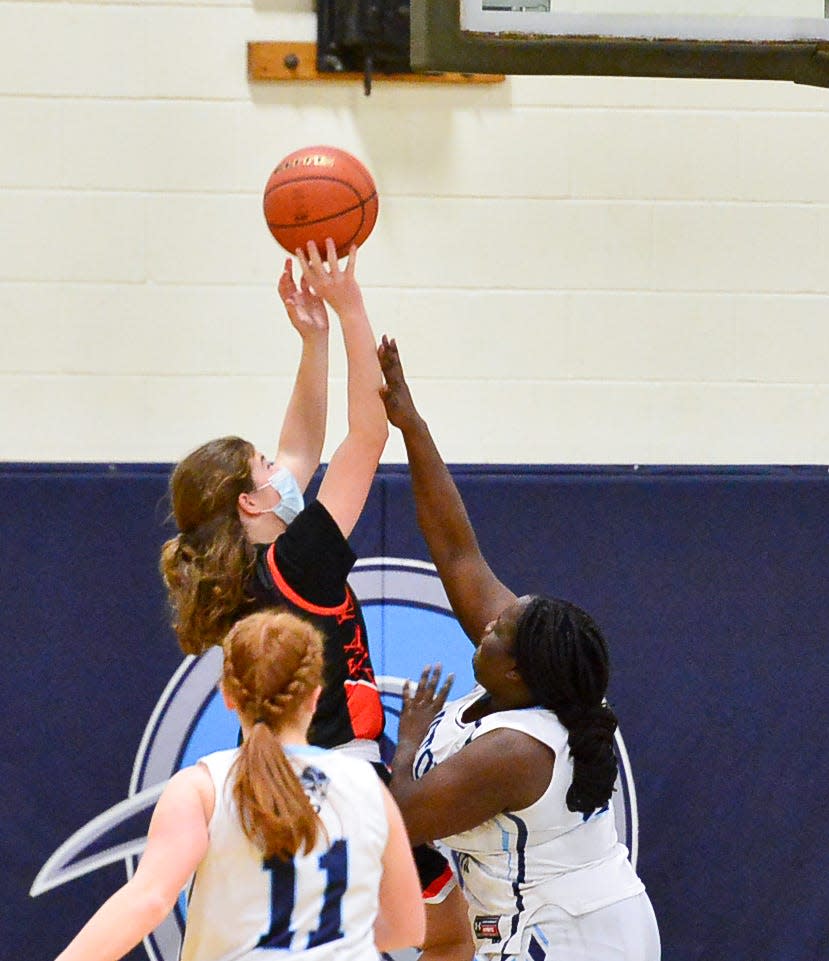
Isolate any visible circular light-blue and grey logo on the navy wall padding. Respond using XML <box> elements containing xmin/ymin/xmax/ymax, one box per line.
<box><xmin>29</xmin><ymin>557</ymin><xmax>638</xmax><ymax>961</ymax></box>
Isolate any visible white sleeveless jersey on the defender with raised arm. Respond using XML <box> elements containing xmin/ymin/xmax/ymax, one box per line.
<box><xmin>414</xmin><ymin>687</ymin><xmax>644</xmax><ymax>955</ymax></box>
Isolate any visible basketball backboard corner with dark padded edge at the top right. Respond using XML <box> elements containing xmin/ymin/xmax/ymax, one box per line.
<box><xmin>411</xmin><ymin>0</ymin><xmax>829</xmax><ymax>87</ymax></box>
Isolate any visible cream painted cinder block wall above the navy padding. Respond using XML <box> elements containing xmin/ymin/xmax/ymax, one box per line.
<box><xmin>0</xmin><ymin>0</ymin><xmax>829</xmax><ymax>463</ymax></box>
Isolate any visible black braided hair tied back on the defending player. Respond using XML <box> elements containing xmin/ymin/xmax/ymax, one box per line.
<box><xmin>515</xmin><ymin>597</ymin><xmax>617</xmax><ymax>814</ymax></box>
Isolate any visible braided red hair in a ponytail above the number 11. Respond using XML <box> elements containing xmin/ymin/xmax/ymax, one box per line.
<box><xmin>222</xmin><ymin>609</ymin><xmax>324</xmax><ymax>861</ymax></box>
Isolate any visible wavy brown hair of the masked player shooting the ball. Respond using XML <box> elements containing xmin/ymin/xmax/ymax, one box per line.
<box><xmin>159</xmin><ymin>437</ymin><xmax>256</xmax><ymax>654</ymax></box>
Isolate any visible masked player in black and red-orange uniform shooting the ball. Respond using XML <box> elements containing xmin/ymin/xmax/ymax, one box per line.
<box><xmin>160</xmin><ymin>242</ymin><xmax>472</xmax><ymax>961</ymax></box>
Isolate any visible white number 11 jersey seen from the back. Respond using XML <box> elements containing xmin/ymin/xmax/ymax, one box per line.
<box><xmin>181</xmin><ymin>747</ymin><xmax>388</xmax><ymax>961</ymax></box>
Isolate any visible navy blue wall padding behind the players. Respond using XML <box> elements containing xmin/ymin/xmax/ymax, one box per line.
<box><xmin>0</xmin><ymin>465</ymin><xmax>829</xmax><ymax>961</ymax></box>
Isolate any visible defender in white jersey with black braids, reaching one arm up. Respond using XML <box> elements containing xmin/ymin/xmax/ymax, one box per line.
<box><xmin>378</xmin><ymin>337</ymin><xmax>660</xmax><ymax>961</ymax></box>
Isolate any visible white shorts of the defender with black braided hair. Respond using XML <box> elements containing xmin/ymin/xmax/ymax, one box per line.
<box><xmin>476</xmin><ymin>891</ymin><xmax>661</xmax><ymax>961</ymax></box>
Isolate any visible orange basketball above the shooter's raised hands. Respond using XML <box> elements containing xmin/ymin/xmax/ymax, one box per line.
<box><xmin>263</xmin><ymin>146</ymin><xmax>378</xmax><ymax>258</ymax></box>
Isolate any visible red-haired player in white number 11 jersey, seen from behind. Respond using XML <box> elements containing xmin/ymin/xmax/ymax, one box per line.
<box><xmin>58</xmin><ymin>610</ymin><xmax>425</xmax><ymax>961</ymax></box>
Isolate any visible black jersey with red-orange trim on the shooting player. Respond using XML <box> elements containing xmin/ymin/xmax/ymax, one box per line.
<box><xmin>251</xmin><ymin>501</ymin><xmax>384</xmax><ymax>748</ymax></box>
